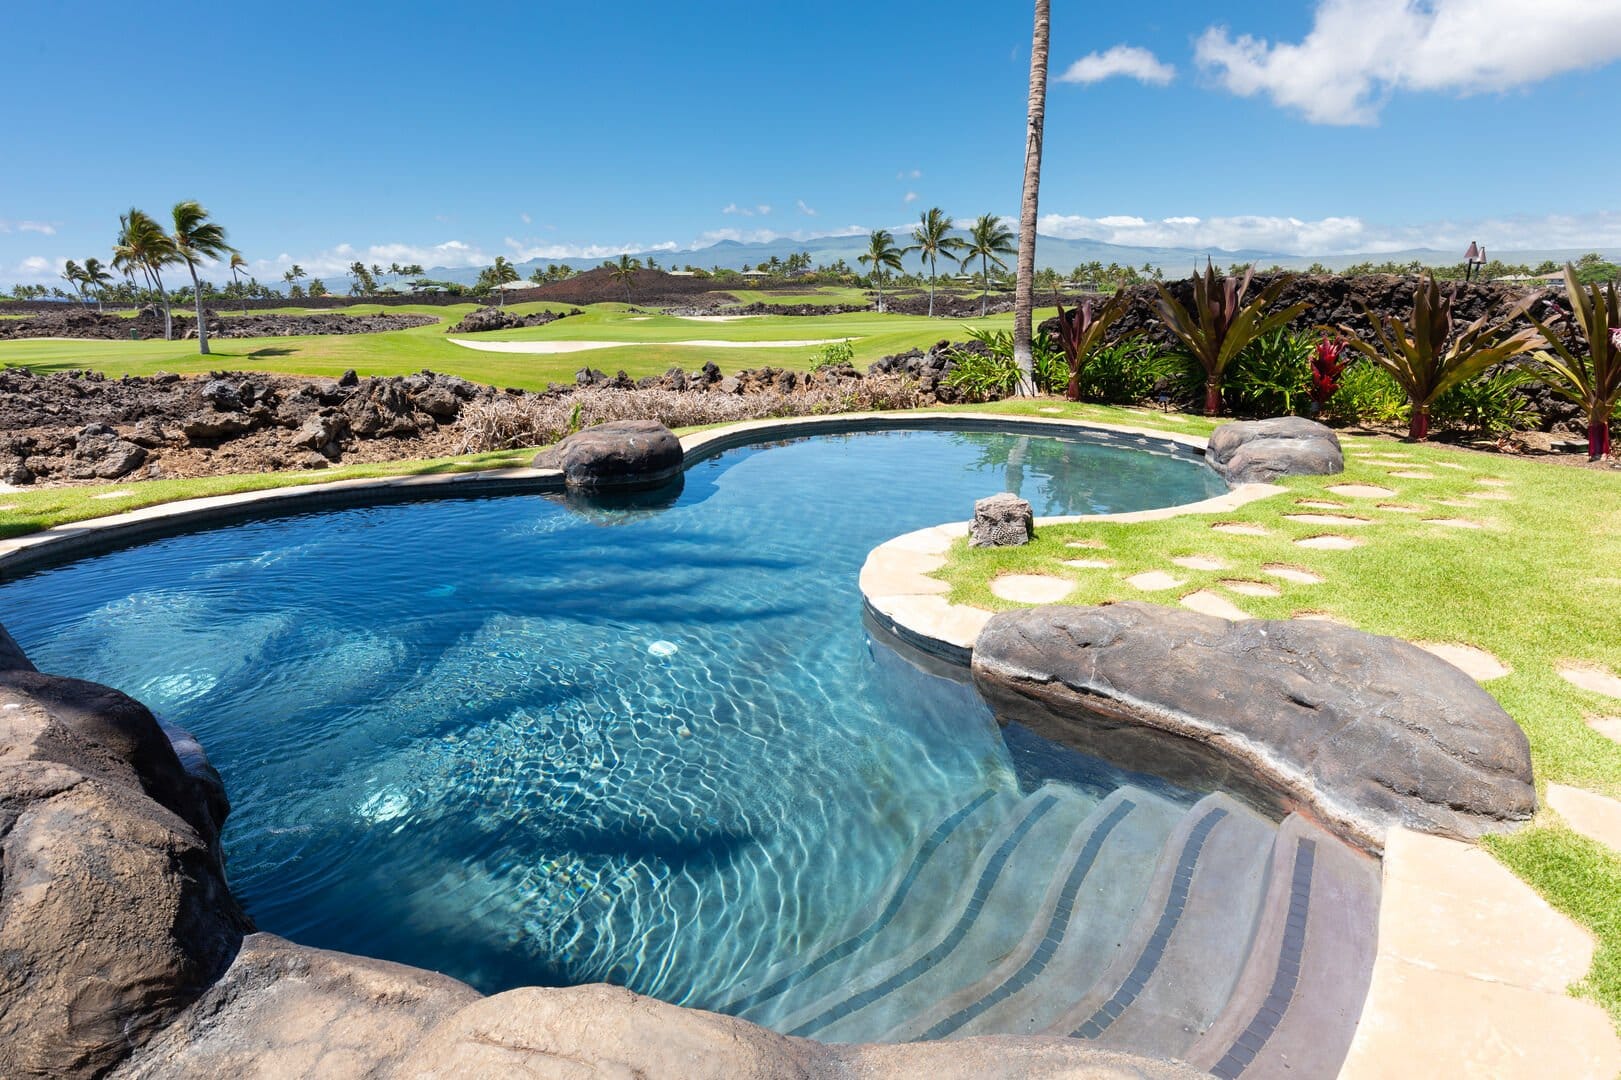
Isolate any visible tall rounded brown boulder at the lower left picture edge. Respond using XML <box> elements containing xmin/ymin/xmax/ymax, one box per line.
<box><xmin>0</xmin><ymin>668</ymin><xmax>250</xmax><ymax>1077</ymax></box>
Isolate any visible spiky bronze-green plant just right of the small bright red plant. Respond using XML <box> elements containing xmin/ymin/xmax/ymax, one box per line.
<box><xmin>1341</xmin><ymin>276</ymin><xmax>1538</xmax><ymax>439</ymax></box>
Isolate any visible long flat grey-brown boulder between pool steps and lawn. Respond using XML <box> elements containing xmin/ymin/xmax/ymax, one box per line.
<box><xmin>973</xmin><ymin>603</ymin><xmax>1537</xmax><ymax>851</ymax></box>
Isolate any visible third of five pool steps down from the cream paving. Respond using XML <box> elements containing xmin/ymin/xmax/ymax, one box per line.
<box><xmin>883</xmin><ymin>788</ymin><xmax>1187</xmax><ymax>1041</ymax></box>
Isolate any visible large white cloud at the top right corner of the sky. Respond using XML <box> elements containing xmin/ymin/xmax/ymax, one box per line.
<box><xmin>1195</xmin><ymin>0</ymin><xmax>1621</xmax><ymax>125</ymax></box>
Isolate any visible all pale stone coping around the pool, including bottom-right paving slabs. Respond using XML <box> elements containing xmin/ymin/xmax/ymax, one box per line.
<box><xmin>0</xmin><ymin>412</ymin><xmax>1621</xmax><ymax>1080</ymax></box>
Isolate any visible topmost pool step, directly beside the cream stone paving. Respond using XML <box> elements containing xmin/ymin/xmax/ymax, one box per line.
<box><xmin>1187</xmin><ymin>814</ymin><xmax>1379</xmax><ymax>1080</ymax></box>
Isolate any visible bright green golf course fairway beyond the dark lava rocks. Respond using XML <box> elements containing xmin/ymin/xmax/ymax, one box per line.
<box><xmin>0</xmin><ymin>303</ymin><xmax>1049</xmax><ymax>389</ymax></box>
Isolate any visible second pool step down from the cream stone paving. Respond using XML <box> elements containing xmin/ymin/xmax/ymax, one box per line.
<box><xmin>1049</xmin><ymin>795</ymin><xmax>1277</xmax><ymax>1059</ymax></box>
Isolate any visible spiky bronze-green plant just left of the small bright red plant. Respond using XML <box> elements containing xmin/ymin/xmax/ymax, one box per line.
<box><xmin>1154</xmin><ymin>259</ymin><xmax>1307</xmax><ymax>417</ymax></box>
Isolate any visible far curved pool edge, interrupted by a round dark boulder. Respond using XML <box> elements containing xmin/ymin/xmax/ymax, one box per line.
<box><xmin>0</xmin><ymin>410</ymin><xmax>1206</xmax><ymax>582</ymax></box>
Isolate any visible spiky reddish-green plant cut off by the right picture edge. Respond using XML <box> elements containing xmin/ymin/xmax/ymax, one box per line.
<box><xmin>1530</xmin><ymin>264</ymin><xmax>1621</xmax><ymax>461</ymax></box>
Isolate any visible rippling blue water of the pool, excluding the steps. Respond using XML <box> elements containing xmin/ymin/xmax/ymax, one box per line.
<box><xmin>0</xmin><ymin>431</ymin><xmax>1224</xmax><ymax>1005</ymax></box>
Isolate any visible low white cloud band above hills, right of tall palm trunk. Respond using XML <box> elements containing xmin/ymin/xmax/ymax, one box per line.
<box><xmin>1039</xmin><ymin>212</ymin><xmax>1621</xmax><ymax>256</ymax></box>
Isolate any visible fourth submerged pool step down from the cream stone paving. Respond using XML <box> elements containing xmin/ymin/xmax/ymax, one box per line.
<box><xmin>780</xmin><ymin>783</ymin><xmax>1097</xmax><ymax>1043</ymax></box>
